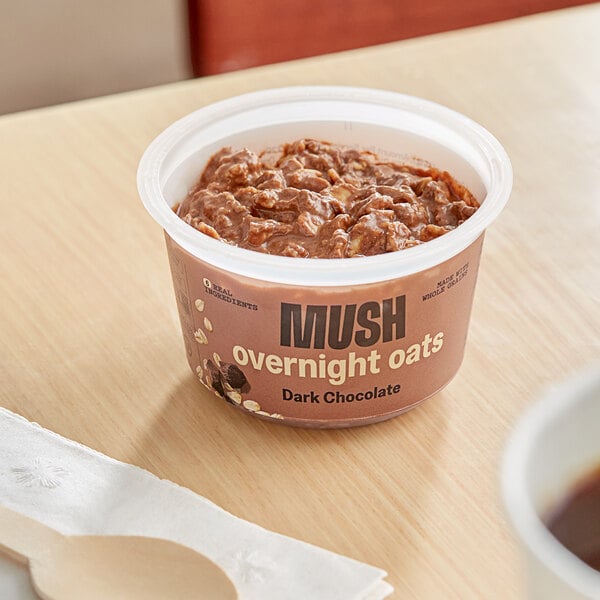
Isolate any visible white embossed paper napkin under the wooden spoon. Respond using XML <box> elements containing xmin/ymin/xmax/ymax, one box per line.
<box><xmin>0</xmin><ymin>408</ymin><xmax>393</xmax><ymax>600</ymax></box>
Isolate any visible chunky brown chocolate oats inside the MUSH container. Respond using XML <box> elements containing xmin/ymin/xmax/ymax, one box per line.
<box><xmin>176</xmin><ymin>139</ymin><xmax>479</xmax><ymax>258</ymax></box>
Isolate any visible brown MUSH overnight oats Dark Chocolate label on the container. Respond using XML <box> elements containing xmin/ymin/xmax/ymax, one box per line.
<box><xmin>166</xmin><ymin>235</ymin><xmax>483</xmax><ymax>426</ymax></box>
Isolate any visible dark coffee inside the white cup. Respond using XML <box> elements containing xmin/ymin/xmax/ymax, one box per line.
<box><xmin>546</xmin><ymin>467</ymin><xmax>600</xmax><ymax>571</ymax></box>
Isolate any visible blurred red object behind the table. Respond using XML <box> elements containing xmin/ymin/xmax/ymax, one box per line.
<box><xmin>188</xmin><ymin>0</ymin><xmax>593</xmax><ymax>76</ymax></box>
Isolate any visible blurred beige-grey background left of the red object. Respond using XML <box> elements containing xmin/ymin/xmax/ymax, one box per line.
<box><xmin>0</xmin><ymin>0</ymin><xmax>192</xmax><ymax>114</ymax></box>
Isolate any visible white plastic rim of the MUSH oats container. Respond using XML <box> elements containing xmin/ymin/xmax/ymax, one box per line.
<box><xmin>137</xmin><ymin>86</ymin><xmax>512</xmax><ymax>286</ymax></box>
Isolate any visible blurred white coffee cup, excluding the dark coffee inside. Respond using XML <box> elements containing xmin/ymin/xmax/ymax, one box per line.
<box><xmin>501</xmin><ymin>366</ymin><xmax>600</xmax><ymax>600</ymax></box>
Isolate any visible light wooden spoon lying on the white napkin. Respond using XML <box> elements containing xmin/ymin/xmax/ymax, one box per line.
<box><xmin>0</xmin><ymin>506</ymin><xmax>238</xmax><ymax>600</ymax></box>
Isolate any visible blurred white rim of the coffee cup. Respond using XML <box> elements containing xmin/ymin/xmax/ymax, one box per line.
<box><xmin>500</xmin><ymin>364</ymin><xmax>600</xmax><ymax>598</ymax></box>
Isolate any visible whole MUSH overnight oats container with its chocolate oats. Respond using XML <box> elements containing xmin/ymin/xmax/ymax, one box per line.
<box><xmin>138</xmin><ymin>87</ymin><xmax>512</xmax><ymax>427</ymax></box>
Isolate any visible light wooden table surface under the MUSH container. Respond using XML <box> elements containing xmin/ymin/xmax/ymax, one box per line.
<box><xmin>0</xmin><ymin>4</ymin><xmax>600</xmax><ymax>599</ymax></box>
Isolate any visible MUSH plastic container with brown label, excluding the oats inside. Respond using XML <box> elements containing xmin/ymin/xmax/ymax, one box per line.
<box><xmin>138</xmin><ymin>87</ymin><xmax>512</xmax><ymax>427</ymax></box>
